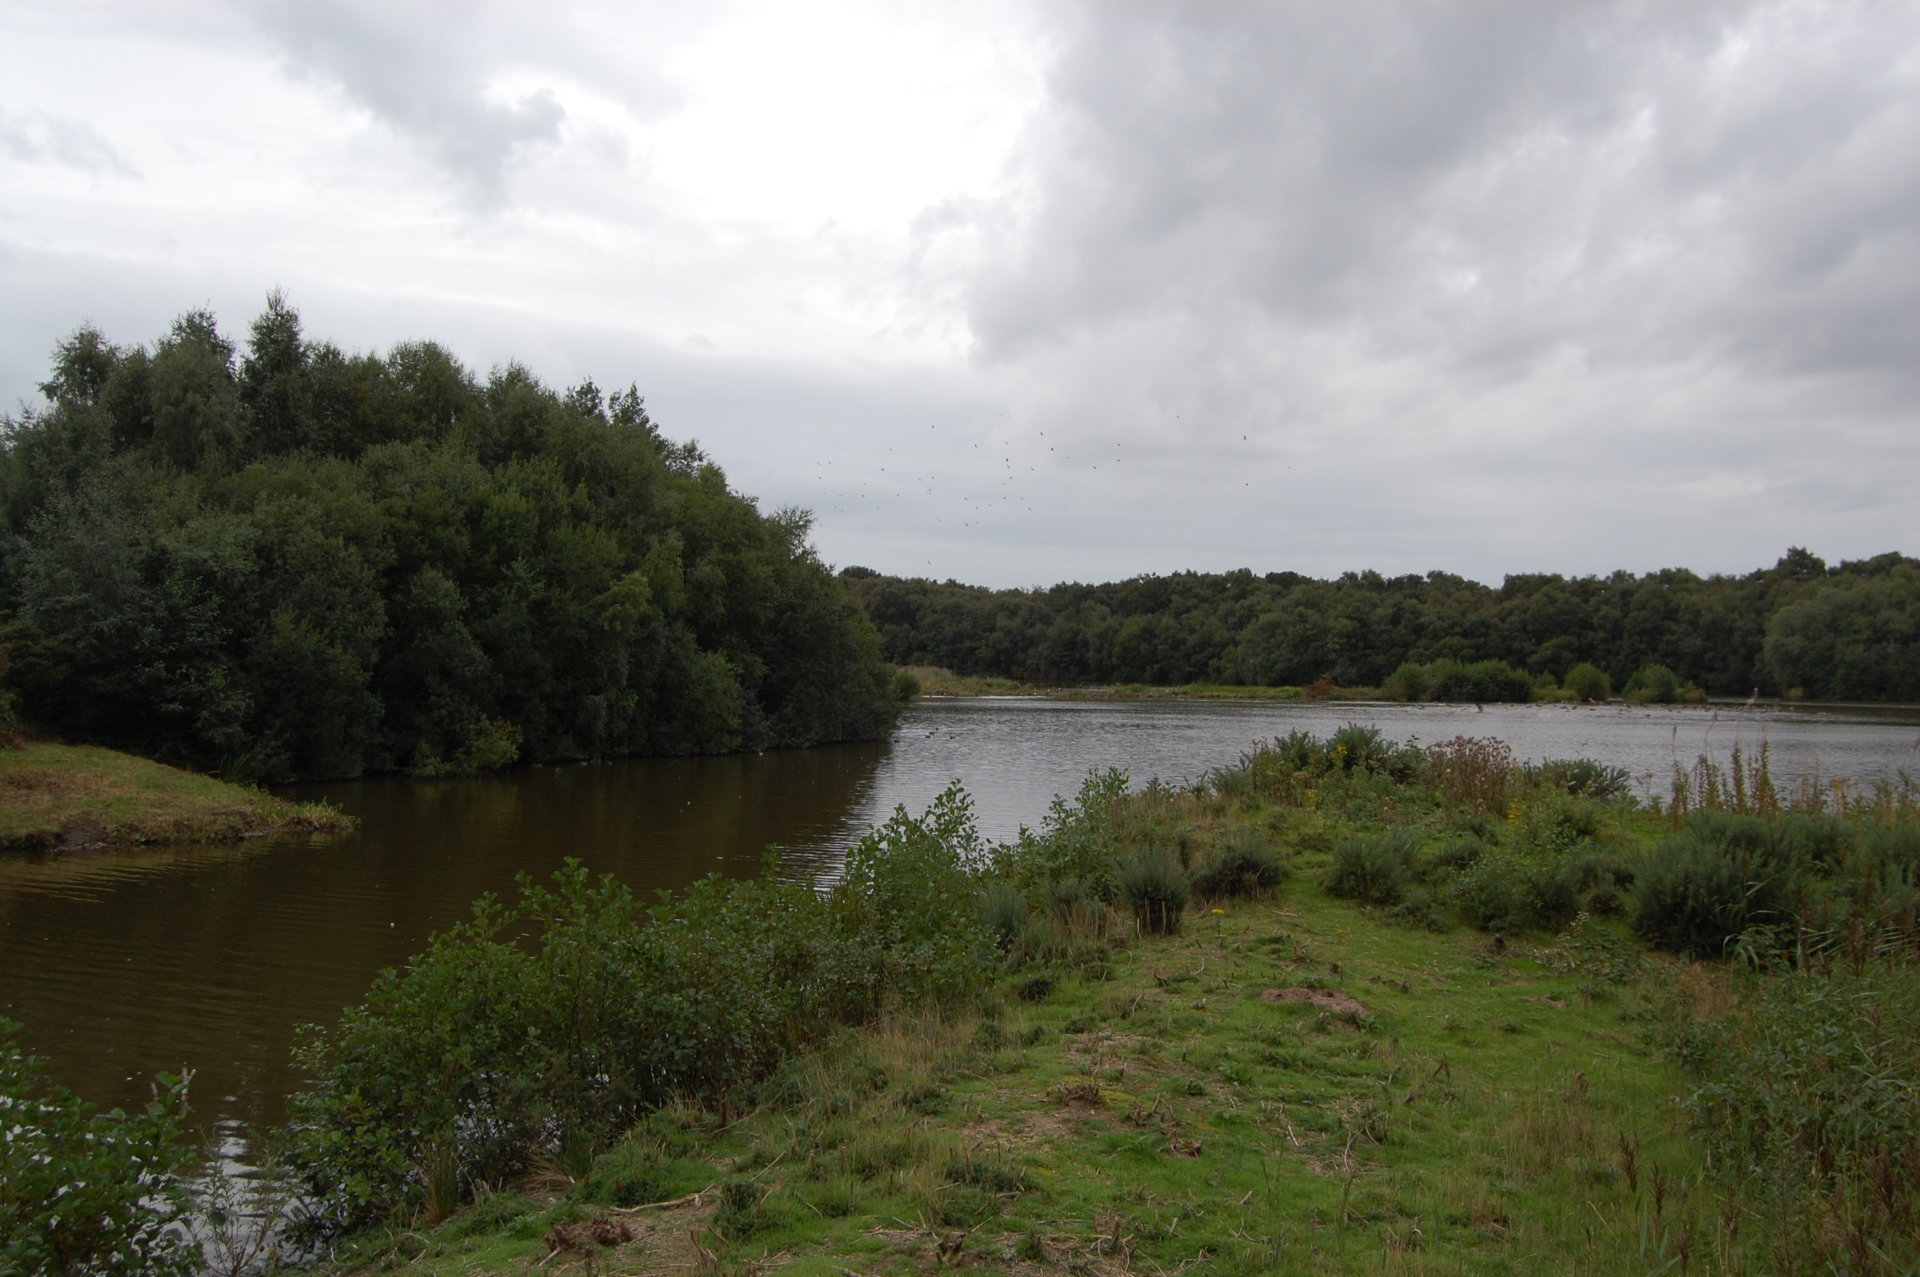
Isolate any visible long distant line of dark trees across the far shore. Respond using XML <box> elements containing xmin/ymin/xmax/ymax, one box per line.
<box><xmin>841</xmin><ymin>547</ymin><xmax>1920</xmax><ymax>701</ymax></box>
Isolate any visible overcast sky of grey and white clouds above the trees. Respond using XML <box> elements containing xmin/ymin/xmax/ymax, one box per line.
<box><xmin>0</xmin><ymin>0</ymin><xmax>1920</xmax><ymax>586</ymax></box>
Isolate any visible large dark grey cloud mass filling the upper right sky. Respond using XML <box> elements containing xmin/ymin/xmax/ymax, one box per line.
<box><xmin>970</xmin><ymin>2</ymin><xmax>1920</xmax><ymax>396</ymax></box>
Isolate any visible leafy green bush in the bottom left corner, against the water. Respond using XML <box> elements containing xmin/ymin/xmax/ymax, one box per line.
<box><xmin>0</xmin><ymin>1018</ymin><xmax>200</xmax><ymax>1275</ymax></box>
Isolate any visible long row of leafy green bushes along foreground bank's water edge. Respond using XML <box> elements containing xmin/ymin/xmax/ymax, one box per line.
<box><xmin>292</xmin><ymin>787</ymin><xmax>991</xmax><ymax>1227</ymax></box>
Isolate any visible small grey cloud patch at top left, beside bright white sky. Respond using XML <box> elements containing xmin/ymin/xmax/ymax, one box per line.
<box><xmin>257</xmin><ymin>0</ymin><xmax>566</xmax><ymax>205</ymax></box>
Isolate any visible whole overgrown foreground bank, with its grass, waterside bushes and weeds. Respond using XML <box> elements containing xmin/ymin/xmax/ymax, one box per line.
<box><xmin>280</xmin><ymin>728</ymin><xmax>1920</xmax><ymax>1277</ymax></box>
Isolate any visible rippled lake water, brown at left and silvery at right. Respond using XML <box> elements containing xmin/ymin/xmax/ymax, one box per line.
<box><xmin>0</xmin><ymin>699</ymin><xmax>1920</xmax><ymax>1125</ymax></box>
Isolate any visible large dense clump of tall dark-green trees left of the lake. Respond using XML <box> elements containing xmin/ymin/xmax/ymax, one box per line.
<box><xmin>0</xmin><ymin>294</ymin><xmax>895</xmax><ymax>780</ymax></box>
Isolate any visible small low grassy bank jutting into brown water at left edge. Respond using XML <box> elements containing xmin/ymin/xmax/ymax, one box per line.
<box><xmin>0</xmin><ymin>743</ymin><xmax>346</xmax><ymax>849</ymax></box>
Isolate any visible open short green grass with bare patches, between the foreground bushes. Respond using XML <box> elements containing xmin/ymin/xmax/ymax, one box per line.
<box><xmin>314</xmin><ymin>885</ymin><xmax>1713</xmax><ymax>1275</ymax></box>
